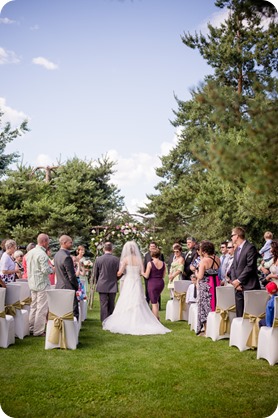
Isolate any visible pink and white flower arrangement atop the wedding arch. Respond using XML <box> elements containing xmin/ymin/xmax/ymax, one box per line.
<box><xmin>90</xmin><ymin>222</ymin><xmax>165</xmax><ymax>257</ymax></box>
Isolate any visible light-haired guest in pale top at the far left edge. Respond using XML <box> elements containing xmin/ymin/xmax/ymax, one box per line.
<box><xmin>0</xmin><ymin>239</ymin><xmax>19</xmax><ymax>283</ymax></box>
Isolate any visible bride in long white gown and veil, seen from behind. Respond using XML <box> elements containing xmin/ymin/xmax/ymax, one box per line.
<box><xmin>102</xmin><ymin>241</ymin><xmax>171</xmax><ymax>335</ymax></box>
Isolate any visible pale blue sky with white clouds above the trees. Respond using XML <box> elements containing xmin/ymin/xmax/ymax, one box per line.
<box><xmin>0</xmin><ymin>0</ymin><xmax>239</xmax><ymax>213</ymax></box>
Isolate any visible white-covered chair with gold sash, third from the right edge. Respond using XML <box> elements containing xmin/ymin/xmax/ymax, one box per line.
<box><xmin>206</xmin><ymin>286</ymin><xmax>236</xmax><ymax>341</ymax></box>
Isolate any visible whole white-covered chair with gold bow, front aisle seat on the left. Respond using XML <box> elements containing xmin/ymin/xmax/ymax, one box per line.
<box><xmin>45</xmin><ymin>289</ymin><xmax>78</xmax><ymax>350</ymax></box>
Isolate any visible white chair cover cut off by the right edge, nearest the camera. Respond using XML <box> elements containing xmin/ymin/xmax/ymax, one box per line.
<box><xmin>257</xmin><ymin>296</ymin><xmax>278</xmax><ymax>366</ymax></box>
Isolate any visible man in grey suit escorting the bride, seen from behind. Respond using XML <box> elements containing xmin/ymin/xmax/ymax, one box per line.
<box><xmin>94</xmin><ymin>242</ymin><xmax>120</xmax><ymax>322</ymax></box>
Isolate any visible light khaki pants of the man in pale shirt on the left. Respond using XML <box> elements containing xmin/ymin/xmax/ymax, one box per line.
<box><xmin>29</xmin><ymin>289</ymin><xmax>48</xmax><ymax>336</ymax></box>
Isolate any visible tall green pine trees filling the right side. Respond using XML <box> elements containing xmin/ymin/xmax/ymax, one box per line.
<box><xmin>141</xmin><ymin>0</ymin><xmax>278</xmax><ymax>244</ymax></box>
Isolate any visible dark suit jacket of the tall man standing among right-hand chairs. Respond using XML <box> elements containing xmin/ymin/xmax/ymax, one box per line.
<box><xmin>231</xmin><ymin>241</ymin><xmax>261</xmax><ymax>290</ymax></box>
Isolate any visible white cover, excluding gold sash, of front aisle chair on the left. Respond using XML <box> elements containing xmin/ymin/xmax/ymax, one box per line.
<box><xmin>45</xmin><ymin>289</ymin><xmax>78</xmax><ymax>350</ymax></box>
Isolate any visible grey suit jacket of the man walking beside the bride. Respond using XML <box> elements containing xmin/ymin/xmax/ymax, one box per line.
<box><xmin>94</xmin><ymin>253</ymin><xmax>120</xmax><ymax>293</ymax></box>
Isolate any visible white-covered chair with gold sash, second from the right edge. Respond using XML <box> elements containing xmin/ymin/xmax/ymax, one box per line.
<box><xmin>229</xmin><ymin>290</ymin><xmax>269</xmax><ymax>351</ymax></box>
